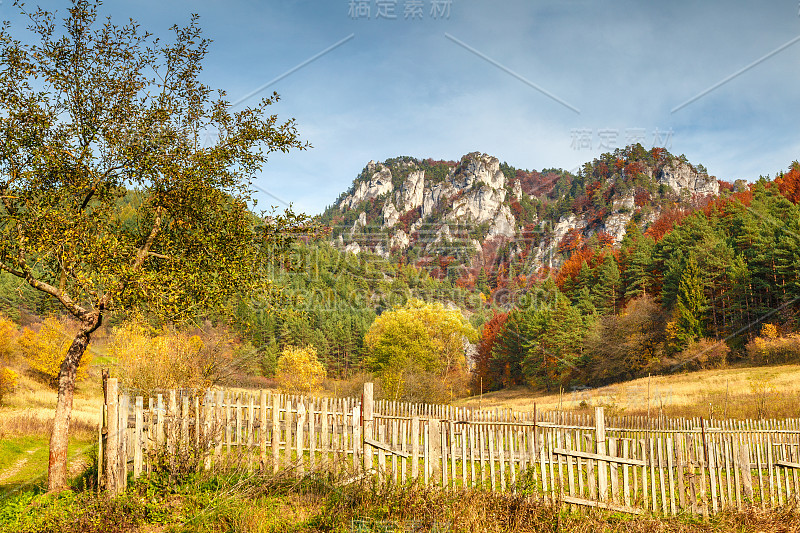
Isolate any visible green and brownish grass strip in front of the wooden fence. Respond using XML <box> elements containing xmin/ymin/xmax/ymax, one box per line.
<box><xmin>0</xmin><ymin>468</ymin><xmax>800</xmax><ymax>533</ymax></box>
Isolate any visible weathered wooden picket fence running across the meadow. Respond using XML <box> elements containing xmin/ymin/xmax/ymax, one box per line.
<box><xmin>99</xmin><ymin>379</ymin><xmax>800</xmax><ymax>516</ymax></box>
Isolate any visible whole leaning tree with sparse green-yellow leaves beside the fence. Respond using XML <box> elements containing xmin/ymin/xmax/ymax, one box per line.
<box><xmin>0</xmin><ymin>0</ymin><xmax>308</xmax><ymax>491</ymax></box>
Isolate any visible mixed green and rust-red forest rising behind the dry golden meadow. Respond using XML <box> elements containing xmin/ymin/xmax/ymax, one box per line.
<box><xmin>475</xmin><ymin>162</ymin><xmax>800</xmax><ymax>390</ymax></box>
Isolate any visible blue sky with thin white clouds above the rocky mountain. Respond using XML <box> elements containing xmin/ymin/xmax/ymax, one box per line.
<box><xmin>0</xmin><ymin>0</ymin><xmax>800</xmax><ymax>214</ymax></box>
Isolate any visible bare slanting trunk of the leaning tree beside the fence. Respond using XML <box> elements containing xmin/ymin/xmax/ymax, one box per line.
<box><xmin>47</xmin><ymin>315</ymin><xmax>100</xmax><ymax>492</ymax></box>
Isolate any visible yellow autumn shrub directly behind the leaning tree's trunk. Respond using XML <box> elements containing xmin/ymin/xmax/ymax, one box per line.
<box><xmin>17</xmin><ymin>317</ymin><xmax>92</xmax><ymax>387</ymax></box>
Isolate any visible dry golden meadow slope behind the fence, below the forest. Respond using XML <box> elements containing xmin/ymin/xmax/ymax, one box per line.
<box><xmin>456</xmin><ymin>365</ymin><xmax>800</xmax><ymax>418</ymax></box>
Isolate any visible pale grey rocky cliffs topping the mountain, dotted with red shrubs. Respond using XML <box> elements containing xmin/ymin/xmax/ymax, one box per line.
<box><xmin>323</xmin><ymin>145</ymin><xmax>720</xmax><ymax>276</ymax></box>
